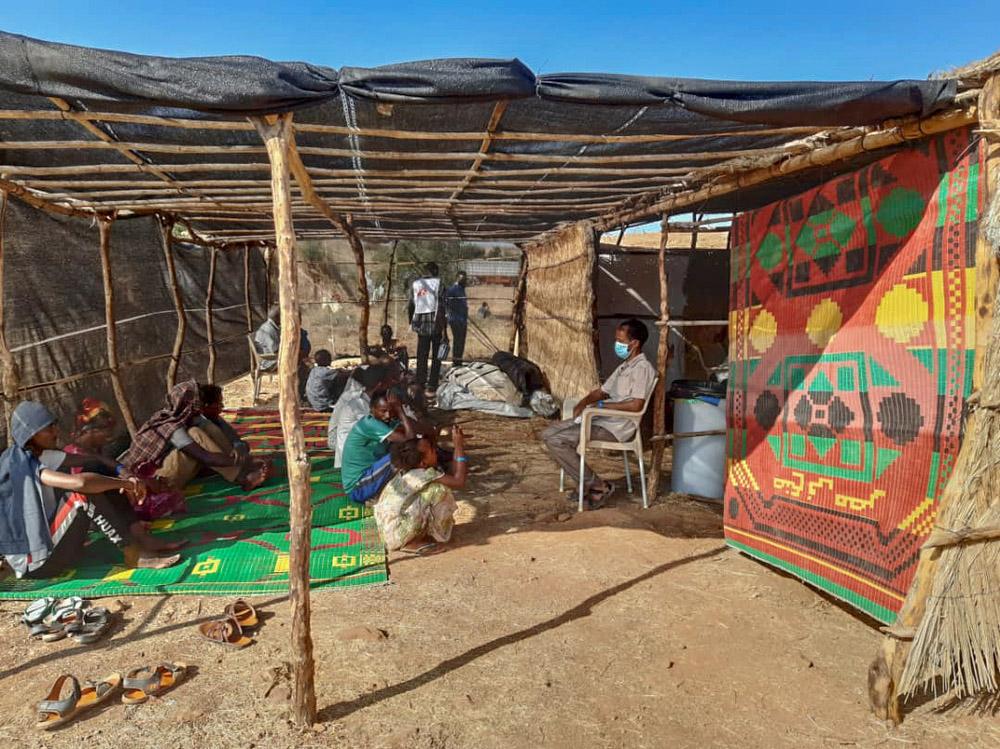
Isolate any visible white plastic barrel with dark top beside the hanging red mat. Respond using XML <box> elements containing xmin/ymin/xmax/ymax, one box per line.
<box><xmin>670</xmin><ymin>398</ymin><xmax>726</xmax><ymax>500</ymax></box>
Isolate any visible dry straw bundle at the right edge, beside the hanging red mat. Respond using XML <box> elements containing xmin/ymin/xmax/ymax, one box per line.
<box><xmin>899</xmin><ymin>174</ymin><xmax>1000</xmax><ymax>698</ymax></box>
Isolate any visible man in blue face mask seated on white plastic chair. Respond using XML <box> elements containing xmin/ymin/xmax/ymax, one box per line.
<box><xmin>542</xmin><ymin>318</ymin><xmax>656</xmax><ymax>509</ymax></box>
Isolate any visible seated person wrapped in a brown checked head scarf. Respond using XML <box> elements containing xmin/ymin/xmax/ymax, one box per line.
<box><xmin>122</xmin><ymin>380</ymin><xmax>267</xmax><ymax>491</ymax></box>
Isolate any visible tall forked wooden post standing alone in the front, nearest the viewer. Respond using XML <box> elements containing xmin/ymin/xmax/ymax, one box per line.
<box><xmin>252</xmin><ymin>114</ymin><xmax>316</xmax><ymax>726</ymax></box>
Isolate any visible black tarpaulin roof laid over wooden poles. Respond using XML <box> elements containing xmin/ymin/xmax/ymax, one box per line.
<box><xmin>0</xmin><ymin>33</ymin><xmax>958</xmax><ymax>241</ymax></box>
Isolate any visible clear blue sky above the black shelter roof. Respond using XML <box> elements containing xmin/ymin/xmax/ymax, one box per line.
<box><xmin>0</xmin><ymin>0</ymin><xmax>1000</xmax><ymax>80</ymax></box>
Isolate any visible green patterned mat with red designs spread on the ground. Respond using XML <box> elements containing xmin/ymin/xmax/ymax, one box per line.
<box><xmin>0</xmin><ymin>409</ymin><xmax>388</xmax><ymax>598</ymax></box>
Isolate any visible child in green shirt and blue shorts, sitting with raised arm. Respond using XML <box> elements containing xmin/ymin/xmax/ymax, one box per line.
<box><xmin>340</xmin><ymin>390</ymin><xmax>417</xmax><ymax>503</ymax></box>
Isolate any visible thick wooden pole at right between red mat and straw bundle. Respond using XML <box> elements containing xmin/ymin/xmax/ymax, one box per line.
<box><xmin>868</xmin><ymin>75</ymin><xmax>1000</xmax><ymax>724</ymax></box>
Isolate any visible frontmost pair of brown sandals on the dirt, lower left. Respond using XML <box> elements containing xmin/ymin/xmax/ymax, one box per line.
<box><xmin>35</xmin><ymin>663</ymin><xmax>187</xmax><ymax>731</ymax></box>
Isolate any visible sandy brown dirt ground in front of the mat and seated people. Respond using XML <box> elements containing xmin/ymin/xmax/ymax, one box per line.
<box><xmin>0</xmin><ymin>376</ymin><xmax>1000</xmax><ymax>749</ymax></box>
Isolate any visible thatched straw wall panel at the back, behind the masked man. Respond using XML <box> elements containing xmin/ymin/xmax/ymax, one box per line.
<box><xmin>521</xmin><ymin>224</ymin><xmax>599</xmax><ymax>398</ymax></box>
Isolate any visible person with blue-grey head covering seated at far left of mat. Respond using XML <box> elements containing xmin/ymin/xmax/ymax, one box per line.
<box><xmin>0</xmin><ymin>401</ymin><xmax>180</xmax><ymax>578</ymax></box>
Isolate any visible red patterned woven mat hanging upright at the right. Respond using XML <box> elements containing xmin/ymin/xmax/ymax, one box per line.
<box><xmin>725</xmin><ymin>129</ymin><xmax>982</xmax><ymax>622</ymax></box>
